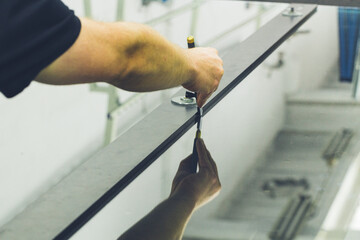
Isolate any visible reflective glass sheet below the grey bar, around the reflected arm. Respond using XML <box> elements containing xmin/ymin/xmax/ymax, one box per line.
<box><xmin>74</xmin><ymin>3</ymin><xmax>360</xmax><ymax>240</ymax></box>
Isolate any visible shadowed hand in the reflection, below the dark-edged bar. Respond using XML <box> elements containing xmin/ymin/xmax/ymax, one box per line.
<box><xmin>170</xmin><ymin>139</ymin><xmax>221</xmax><ymax>209</ymax></box>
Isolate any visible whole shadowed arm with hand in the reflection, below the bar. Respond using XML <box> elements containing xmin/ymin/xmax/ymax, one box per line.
<box><xmin>119</xmin><ymin>139</ymin><xmax>221</xmax><ymax>240</ymax></box>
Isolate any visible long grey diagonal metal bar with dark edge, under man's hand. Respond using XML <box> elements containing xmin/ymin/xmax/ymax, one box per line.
<box><xmin>0</xmin><ymin>5</ymin><xmax>316</xmax><ymax>239</ymax></box>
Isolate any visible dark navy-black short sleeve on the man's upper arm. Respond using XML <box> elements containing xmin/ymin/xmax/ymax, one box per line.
<box><xmin>0</xmin><ymin>0</ymin><xmax>81</xmax><ymax>97</ymax></box>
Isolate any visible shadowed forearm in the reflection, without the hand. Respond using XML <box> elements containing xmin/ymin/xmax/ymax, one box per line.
<box><xmin>119</xmin><ymin>198</ymin><xmax>195</xmax><ymax>240</ymax></box>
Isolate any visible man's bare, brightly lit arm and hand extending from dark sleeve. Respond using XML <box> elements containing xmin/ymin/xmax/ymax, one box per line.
<box><xmin>36</xmin><ymin>19</ymin><xmax>223</xmax><ymax>105</ymax></box>
